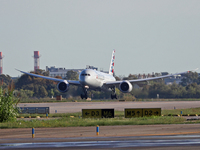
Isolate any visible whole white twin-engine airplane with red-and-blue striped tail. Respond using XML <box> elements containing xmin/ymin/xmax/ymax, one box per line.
<box><xmin>16</xmin><ymin>50</ymin><xmax>198</xmax><ymax>99</ymax></box>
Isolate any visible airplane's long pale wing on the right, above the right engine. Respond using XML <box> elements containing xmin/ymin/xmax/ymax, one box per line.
<box><xmin>104</xmin><ymin>68</ymin><xmax>198</xmax><ymax>86</ymax></box>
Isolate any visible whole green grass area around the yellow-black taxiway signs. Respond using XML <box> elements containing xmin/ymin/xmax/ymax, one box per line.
<box><xmin>0</xmin><ymin>108</ymin><xmax>200</xmax><ymax>129</ymax></box>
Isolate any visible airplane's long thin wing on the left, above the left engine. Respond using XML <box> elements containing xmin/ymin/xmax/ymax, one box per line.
<box><xmin>16</xmin><ymin>69</ymin><xmax>81</xmax><ymax>85</ymax></box>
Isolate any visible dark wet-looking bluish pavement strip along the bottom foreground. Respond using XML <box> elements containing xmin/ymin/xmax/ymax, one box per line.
<box><xmin>0</xmin><ymin>135</ymin><xmax>200</xmax><ymax>149</ymax></box>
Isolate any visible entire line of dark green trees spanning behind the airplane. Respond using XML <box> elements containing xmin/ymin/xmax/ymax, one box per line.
<box><xmin>0</xmin><ymin>69</ymin><xmax>200</xmax><ymax>99</ymax></box>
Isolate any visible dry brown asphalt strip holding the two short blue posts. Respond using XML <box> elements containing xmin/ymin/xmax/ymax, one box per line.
<box><xmin>0</xmin><ymin>124</ymin><xmax>200</xmax><ymax>140</ymax></box>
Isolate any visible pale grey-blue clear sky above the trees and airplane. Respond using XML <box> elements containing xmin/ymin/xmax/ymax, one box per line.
<box><xmin>0</xmin><ymin>0</ymin><xmax>200</xmax><ymax>77</ymax></box>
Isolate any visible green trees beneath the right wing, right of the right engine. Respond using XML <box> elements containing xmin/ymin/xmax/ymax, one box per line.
<box><xmin>127</xmin><ymin>72</ymin><xmax>200</xmax><ymax>98</ymax></box>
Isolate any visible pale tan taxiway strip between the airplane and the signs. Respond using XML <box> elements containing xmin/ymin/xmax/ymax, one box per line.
<box><xmin>19</xmin><ymin>101</ymin><xmax>200</xmax><ymax>113</ymax></box>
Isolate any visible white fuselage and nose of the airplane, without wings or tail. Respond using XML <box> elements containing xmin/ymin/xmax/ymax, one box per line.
<box><xmin>79</xmin><ymin>69</ymin><xmax>116</xmax><ymax>90</ymax></box>
